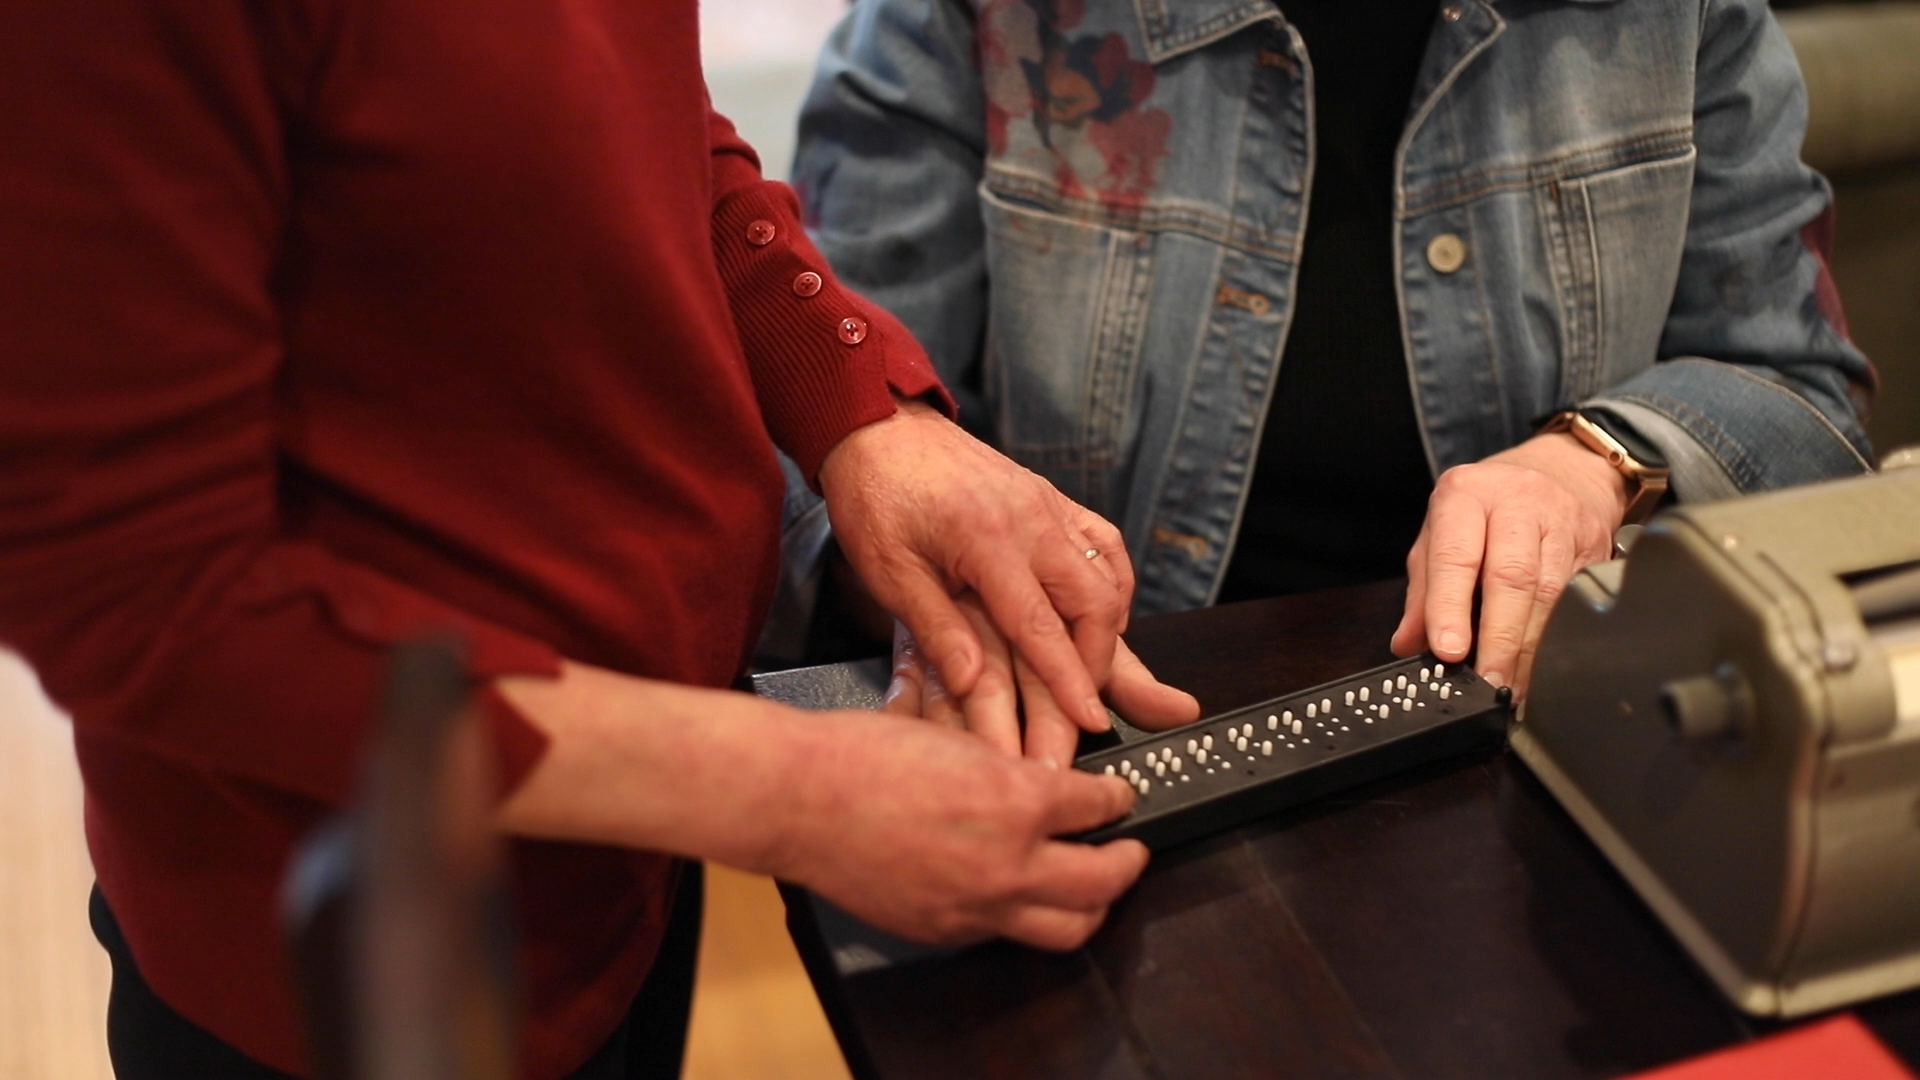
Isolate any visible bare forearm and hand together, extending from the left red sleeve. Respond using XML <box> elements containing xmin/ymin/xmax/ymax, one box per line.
<box><xmin>493</xmin><ymin>661</ymin><xmax>1146</xmax><ymax>949</ymax></box>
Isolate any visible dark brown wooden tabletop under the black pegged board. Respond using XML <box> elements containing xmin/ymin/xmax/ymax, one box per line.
<box><xmin>756</xmin><ymin>584</ymin><xmax>1920</xmax><ymax>1080</ymax></box>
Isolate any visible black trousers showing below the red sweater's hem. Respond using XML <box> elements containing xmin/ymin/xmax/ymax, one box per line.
<box><xmin>88</xmin><ymin>863</ymin><xmax>705</xmax><ymax>1080</ymax></box>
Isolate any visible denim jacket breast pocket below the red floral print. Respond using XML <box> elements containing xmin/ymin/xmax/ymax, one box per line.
<box><xmin>981</xmin><ymin>175</ymin><xmax>1154</xmax><ymax>513</ymax></box>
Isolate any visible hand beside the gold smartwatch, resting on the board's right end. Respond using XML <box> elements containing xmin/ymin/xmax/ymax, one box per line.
<box><xmin>1392</xmin><ymin>432</ymin><xmax>1626</xmax><ymax>698</ymax></box>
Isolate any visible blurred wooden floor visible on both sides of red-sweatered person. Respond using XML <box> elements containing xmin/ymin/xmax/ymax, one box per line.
<box><xmin>0</xmin><ymin>653</ymin><xmax>847</xmax><ymax>1080</ymax></box>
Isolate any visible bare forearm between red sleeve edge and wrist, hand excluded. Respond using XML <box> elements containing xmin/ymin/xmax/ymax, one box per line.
<box><xmin>495</xmin><ymin>663</ymin><xmax>817</xmax><ymax>872</ymax></box>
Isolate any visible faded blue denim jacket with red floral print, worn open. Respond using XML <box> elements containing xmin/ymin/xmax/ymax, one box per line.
<box><xmin>764</xmin><ymin>0</ymin><xmax>1872</xmax><ymax>641</ymax></box>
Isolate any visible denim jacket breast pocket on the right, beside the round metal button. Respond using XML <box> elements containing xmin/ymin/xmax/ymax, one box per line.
<box><xmin>1534</xmin><ymin>144</ymin><xmax>1695</xmax><ymax>404</ymax></box>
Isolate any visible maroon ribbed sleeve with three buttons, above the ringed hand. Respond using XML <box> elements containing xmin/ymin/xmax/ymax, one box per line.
<box><xmin>708</xmin><ymin>110</ymin><xmax>956</xmax><ymax>482</ymax></box>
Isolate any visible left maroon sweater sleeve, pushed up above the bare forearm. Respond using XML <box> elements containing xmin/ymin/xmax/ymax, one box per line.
<box><xmin>0</xmin><ymin>4</ymin><xmax>557</xmax><ymax>801</ymax></box>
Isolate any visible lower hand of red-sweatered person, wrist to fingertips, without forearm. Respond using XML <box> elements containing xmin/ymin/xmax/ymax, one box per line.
<box><xmin>755</xmin><ymin>713</ymin><xmax>1146</xmax><ymax>949</ymax></box>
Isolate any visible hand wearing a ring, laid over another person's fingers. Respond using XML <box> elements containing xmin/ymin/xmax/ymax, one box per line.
<box><xmin>820</xmin><ymin>402</ymin><xmax>1133</xmax><ymax>730</ymax></box>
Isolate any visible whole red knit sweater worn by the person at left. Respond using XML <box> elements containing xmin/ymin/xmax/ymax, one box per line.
<box><xmin>0</xmin><ymin>0</ymin><xmax>941</xmax><ymax>1078</ymax></box>
